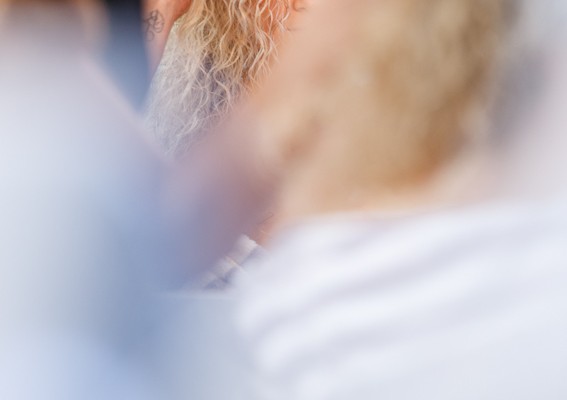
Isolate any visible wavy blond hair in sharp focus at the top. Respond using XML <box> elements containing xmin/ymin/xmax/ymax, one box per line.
<box><xmin>145</xmin><ymin>0</ymin><xmax>290</xmax><ymax>159</ymax></box>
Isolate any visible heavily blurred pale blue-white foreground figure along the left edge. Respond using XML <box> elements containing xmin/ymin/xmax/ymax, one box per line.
<box><xmin>0</xmin><ymin>6</ymin><xmax>166</xmax><ymax>400</ymax></box>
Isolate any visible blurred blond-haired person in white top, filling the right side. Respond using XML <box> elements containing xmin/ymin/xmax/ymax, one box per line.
<box><xmin>234</xmin><ymin>0</ymin><xmax>567</xmax><ymax>400</ymax></box>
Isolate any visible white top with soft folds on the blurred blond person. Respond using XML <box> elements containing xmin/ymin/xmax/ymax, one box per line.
<box><xmin>238</xmin><ymin>201</ymin><xmax>567</xmax><ymax>400</ymax></box>
